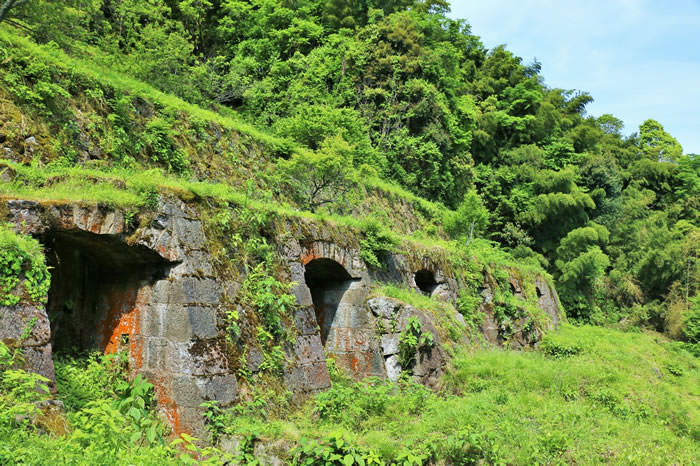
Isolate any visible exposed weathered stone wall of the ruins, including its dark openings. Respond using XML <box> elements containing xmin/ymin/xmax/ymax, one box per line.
<box><xmin>0</xmin><ymin>199</ymin><xmax>559</xmax><ymax>435</ymax></box>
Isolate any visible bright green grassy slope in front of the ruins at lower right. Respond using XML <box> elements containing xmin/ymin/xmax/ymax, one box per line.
<box><xmin>230</xmin><ymin>325</ymin><xmax>700</xmax><ymax>465</ymax></box>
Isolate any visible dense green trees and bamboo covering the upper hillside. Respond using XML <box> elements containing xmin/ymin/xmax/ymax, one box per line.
<box><xmin>8</xmin><ymin>0</ymin><xmax>700</xmax><ymax>337</ymax></box>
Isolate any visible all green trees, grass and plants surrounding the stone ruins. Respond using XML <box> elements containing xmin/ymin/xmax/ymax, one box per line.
<box><xmin>0</xmin><ymin>0</ymin><xmax>700</xmax><ymax>464</ymax></box>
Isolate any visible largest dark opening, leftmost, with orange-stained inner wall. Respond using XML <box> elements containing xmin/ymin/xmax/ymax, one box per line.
<box><xmin>42</xmin><ymin>231</ymin><xmax>170</xmax><ymax>354</ymax></box>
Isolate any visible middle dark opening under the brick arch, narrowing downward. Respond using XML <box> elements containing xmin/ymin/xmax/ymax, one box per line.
<box><xmin>304</xmin><ymin>258</ymin><xmax>353</xmax><ymax>345</ymax></box>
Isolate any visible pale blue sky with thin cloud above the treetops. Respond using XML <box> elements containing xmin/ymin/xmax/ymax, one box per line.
<box><xmin>450</xmin><ymin>0</ymin><xmax>700</xmax><ymax>154</ymax></box>
